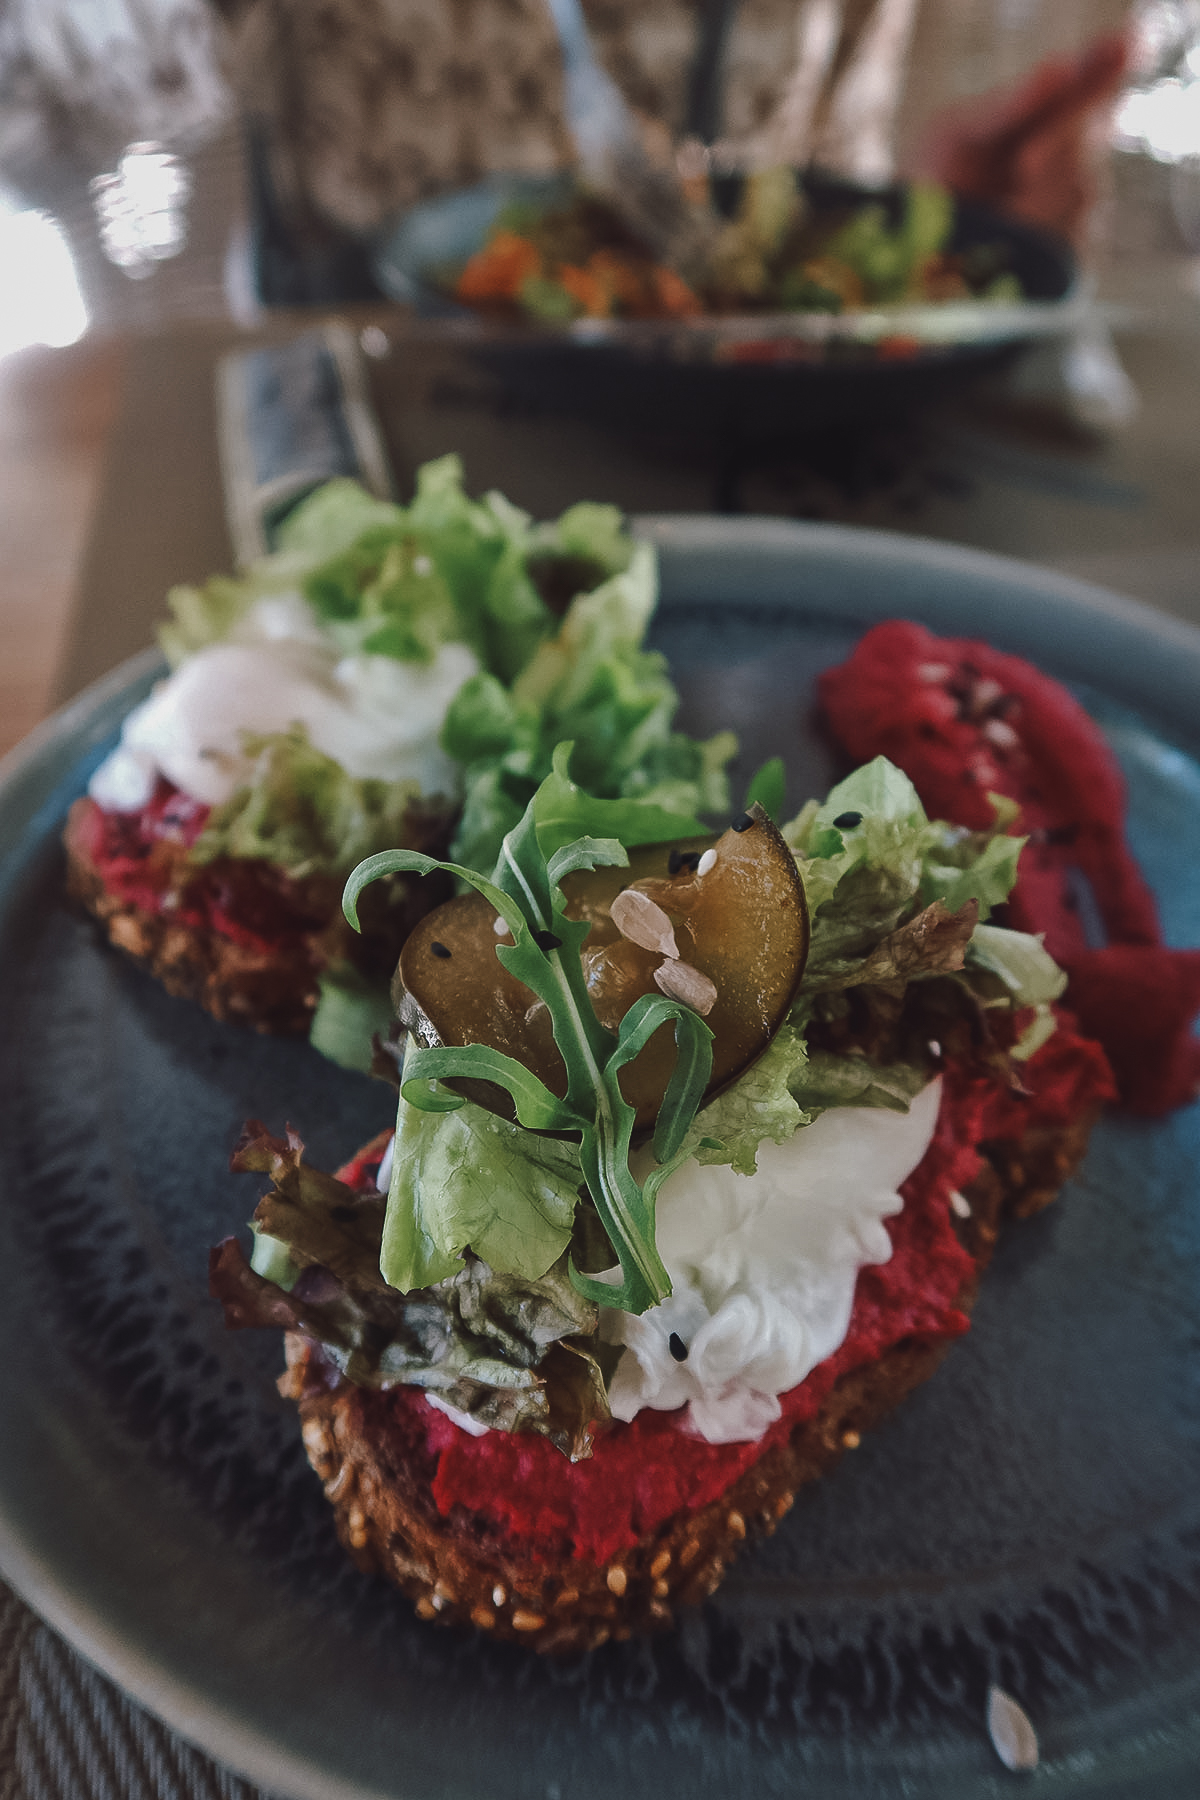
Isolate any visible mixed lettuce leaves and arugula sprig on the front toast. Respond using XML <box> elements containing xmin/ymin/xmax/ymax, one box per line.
<box><xmin>223</xmin><ymin>745</ymin><xmax>1063</xmax><ymax>1456</ymax></box>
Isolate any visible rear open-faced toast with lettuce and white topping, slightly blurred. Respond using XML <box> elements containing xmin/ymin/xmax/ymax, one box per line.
<box><xmin>67</xmin><ymin>457</ymin><xmax>732</xmax><ymax>1058</ymax></box>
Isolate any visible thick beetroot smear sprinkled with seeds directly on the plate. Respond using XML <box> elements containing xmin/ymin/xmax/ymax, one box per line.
<box><xmin>819</xmin><ymin>619</ymin><xmax>1200</xmax><ymax>1114</ymax></box>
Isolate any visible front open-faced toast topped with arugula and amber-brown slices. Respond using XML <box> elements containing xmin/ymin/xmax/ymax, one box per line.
<box><xmin>212</xmin><ymin>749</ymin><xmax>1112</xmax><ymax>1651</ymax></box>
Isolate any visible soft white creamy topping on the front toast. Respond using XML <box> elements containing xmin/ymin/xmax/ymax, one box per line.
<box><xmin>601</xmin><ymin>1080</ymin><xmax>941</xmax><ymax>1444</ymax></box>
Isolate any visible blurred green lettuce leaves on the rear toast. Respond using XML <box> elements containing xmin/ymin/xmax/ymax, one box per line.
<box><xmin>160</xmin><ymin>455</ymin><xmax>736</xmax><ymax>892</ymax></box>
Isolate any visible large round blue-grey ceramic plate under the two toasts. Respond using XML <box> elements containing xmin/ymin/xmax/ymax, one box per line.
<box><xmin>0</xmin><ymin>518</ymin><xmax>1200</xmax><ymax>1800</ymax></box>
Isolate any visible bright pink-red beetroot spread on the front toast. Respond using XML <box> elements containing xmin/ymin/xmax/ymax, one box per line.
<box><xmin>342</xmin><ymin>1021</ymin><xmax>1110</xmax><ymax>1564</ymax></box>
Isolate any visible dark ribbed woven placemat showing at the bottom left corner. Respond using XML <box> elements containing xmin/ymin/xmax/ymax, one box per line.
<box><xmin>0</xmin><ymin>1582</ymin><xmax>268</xmax><ymax>1800</ymax></box>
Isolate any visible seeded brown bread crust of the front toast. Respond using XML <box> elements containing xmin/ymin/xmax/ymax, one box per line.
<box><xmin>281</xmin><ymin>1111</ymin><xmax>1096</xmax><ymax>1652</ymax></box>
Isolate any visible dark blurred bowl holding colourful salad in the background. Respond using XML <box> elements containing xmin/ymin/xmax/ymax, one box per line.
<box><xmin>372</xmin><ymin>175</ymin><xmax>1087</xmax><ymax>452</ymax></box>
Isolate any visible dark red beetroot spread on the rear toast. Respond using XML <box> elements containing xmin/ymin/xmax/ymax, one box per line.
<box><xmin>68</xmin><ymin>779</ymin><xmax>329</xmax><ymax>954</ymax></box>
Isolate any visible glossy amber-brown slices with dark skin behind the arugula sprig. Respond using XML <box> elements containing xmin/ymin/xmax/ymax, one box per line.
<box><xmin>398</xmin><ymin>806</ymin><xmax>808</xmax><ymax>1129</ymax></box>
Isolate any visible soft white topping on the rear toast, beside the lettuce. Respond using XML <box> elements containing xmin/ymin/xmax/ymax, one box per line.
<box><xmin>88</xmin><ymin>592</ymin><xmax>479</xmax><ymax>812</ymax></box>
